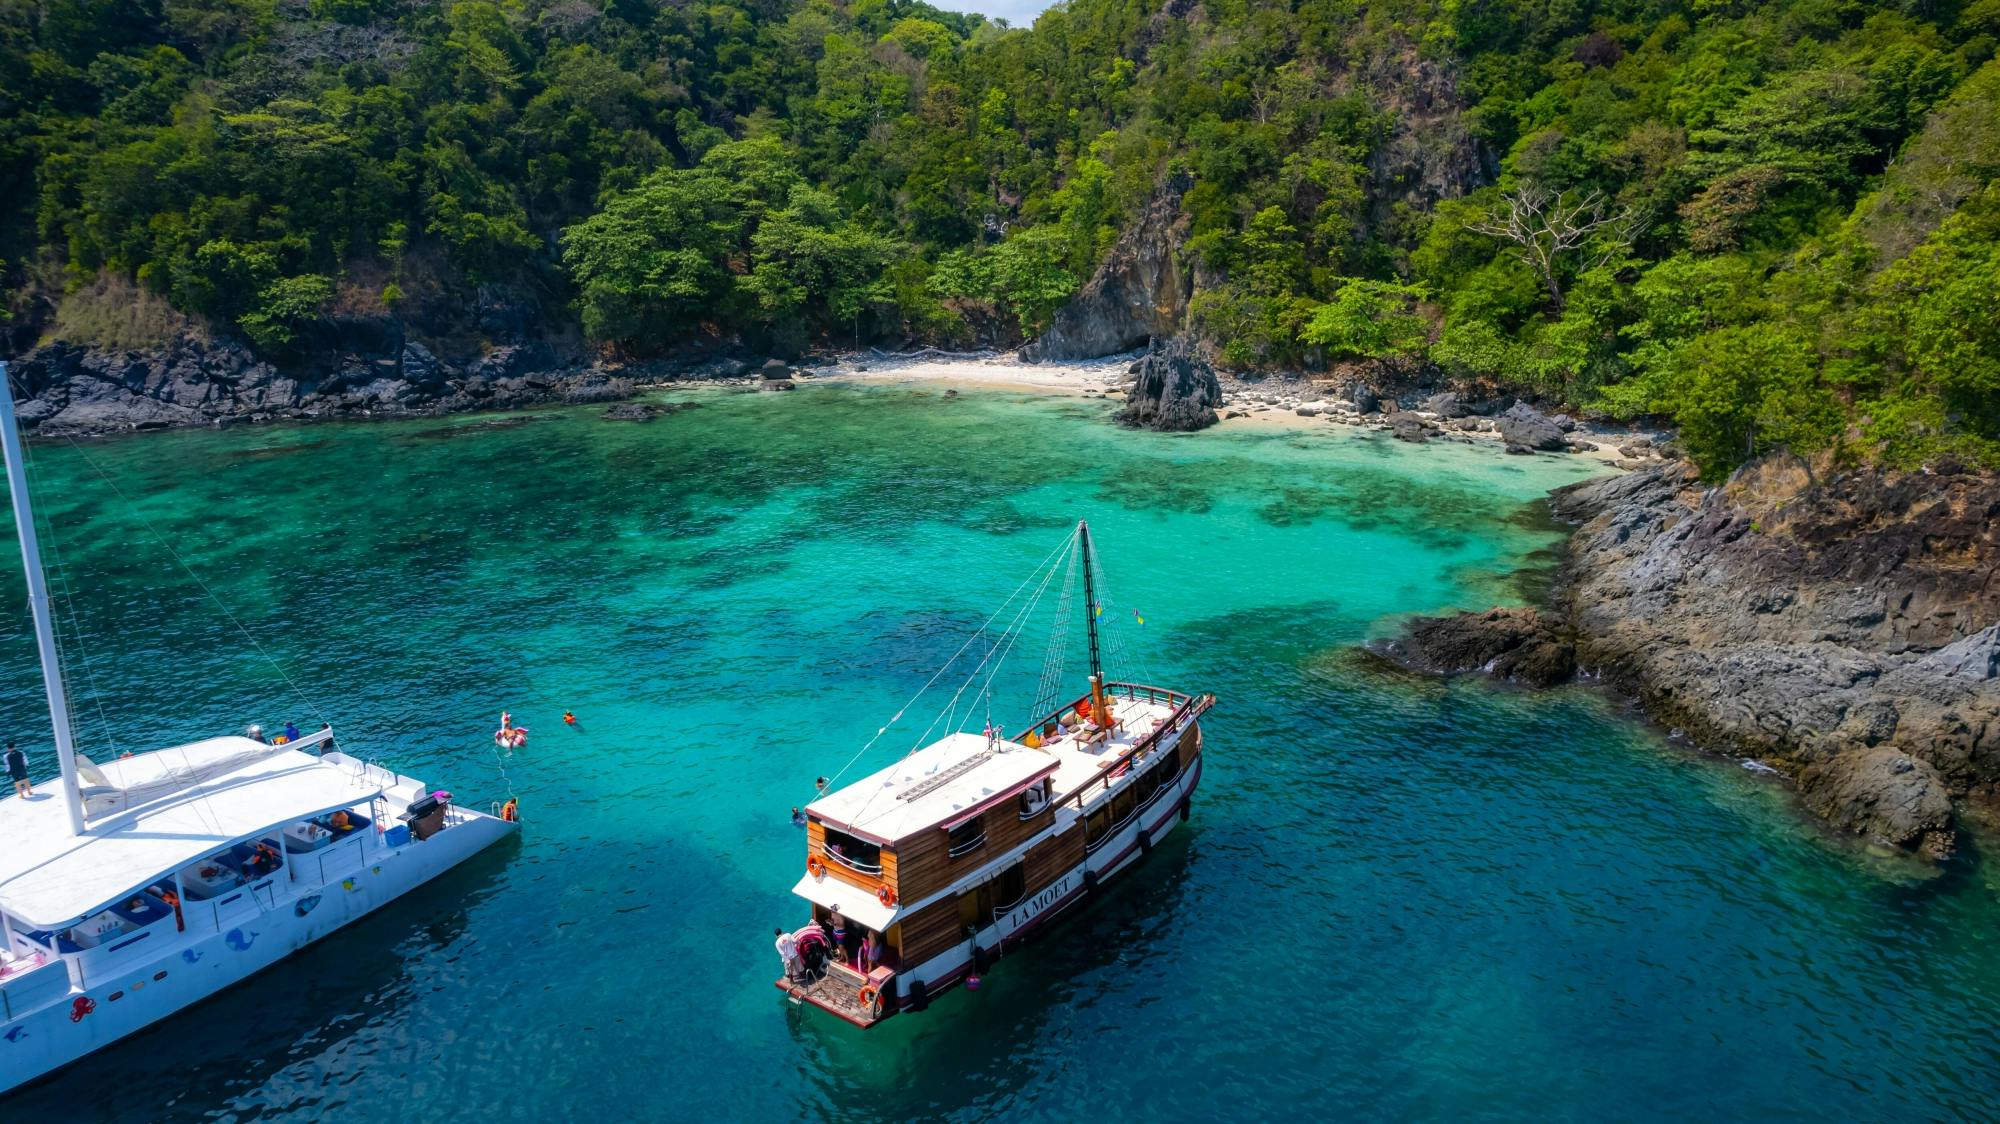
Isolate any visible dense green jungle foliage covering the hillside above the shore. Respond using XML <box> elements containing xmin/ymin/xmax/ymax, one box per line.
<box><xmin>0</xmin><ymin>0</ymin><xmax>2000</xmax><ymax>472</ymax></box>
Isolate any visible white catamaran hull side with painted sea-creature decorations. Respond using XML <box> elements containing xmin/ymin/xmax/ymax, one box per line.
<box><xmin>0</xmin><ymin>808</ymin><xmax>518</xmax><ymax>1094</ymax></box>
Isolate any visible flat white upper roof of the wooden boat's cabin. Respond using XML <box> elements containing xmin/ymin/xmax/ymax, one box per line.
<box><xmin>806</xmin><ymin>732</ymin><xmax>1056</xmax><ymax>842</ymax></box>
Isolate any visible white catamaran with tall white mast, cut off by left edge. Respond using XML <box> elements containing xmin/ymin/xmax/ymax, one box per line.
<box><xmin>0</xmin><ymin>364</ymin><xmax>516</xmax><ymax>1094</ymax></box>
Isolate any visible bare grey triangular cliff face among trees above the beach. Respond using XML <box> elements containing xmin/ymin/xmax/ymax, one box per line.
<box><xmin>1020</xmin><ymin>186</ymin><xmax>1194</xmax><ymax>362</ymax></box>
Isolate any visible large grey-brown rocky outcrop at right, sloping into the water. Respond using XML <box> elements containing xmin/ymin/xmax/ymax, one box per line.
<box><xmin>1384</xmin><ymin>456</ymin><xmax>2000</xmax><ymax>856</ymax></box>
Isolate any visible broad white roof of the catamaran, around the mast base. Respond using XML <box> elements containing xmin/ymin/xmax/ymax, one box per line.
<box><xmin>0</xmin><ymin>736</ymin><xmax>382</xmax><ymax>928</ymax></box>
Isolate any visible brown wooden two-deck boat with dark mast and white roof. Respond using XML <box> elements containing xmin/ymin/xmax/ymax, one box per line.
<box><xmin>778</xmin><ymin>524</ymin><xmax>1214</xmax><ymax>1028</ymax></box>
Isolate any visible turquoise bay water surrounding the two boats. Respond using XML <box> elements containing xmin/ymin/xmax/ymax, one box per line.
<box><xmin>0</xmin><ymin>388</ymin><xmax>2000</xmax><ymax>1122</ymax></box>
